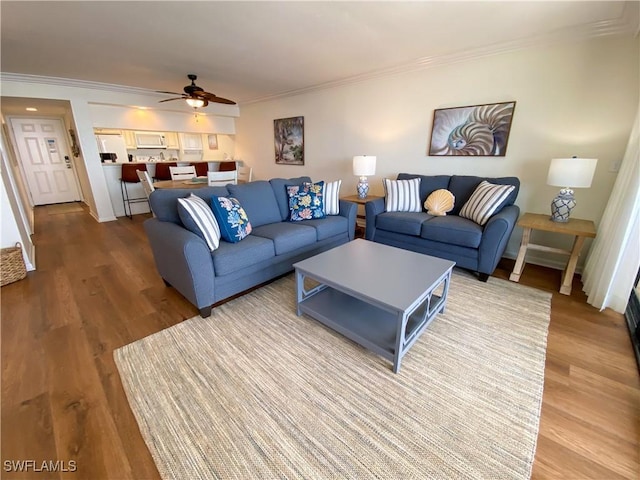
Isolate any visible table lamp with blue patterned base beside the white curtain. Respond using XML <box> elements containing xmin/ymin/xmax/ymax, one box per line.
<box><xmin>547</xmin><ymin>157</ymin><xmax>598</xmax><ymax>223</ymax></box>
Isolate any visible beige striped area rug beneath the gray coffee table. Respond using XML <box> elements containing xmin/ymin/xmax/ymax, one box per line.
<box><xmin>115</xmin><ymin>273</ymin><xmax>551</xmax><ymax>479</ymax></box>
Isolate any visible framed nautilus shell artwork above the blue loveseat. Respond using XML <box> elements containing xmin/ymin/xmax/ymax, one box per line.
<box><xmin>429</xmin><ymin>102</ymin><xmax>516</xmax><ymax>157</ymax></box>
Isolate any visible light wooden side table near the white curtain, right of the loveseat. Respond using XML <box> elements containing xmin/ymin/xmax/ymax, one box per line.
<box><xmin>509</xmin><ymin>213</ymin><xmax>596</xmax><ymax>295</ymax></box>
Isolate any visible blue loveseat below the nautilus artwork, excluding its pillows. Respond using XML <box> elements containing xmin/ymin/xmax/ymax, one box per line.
<box><xmin>365</xmin><ymin>173</ymin><xmax>520</xmax><ymax>282</ymax></box>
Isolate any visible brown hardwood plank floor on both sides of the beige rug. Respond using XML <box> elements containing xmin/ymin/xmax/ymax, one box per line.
<box><xmin>1</xmin><ymin>207</ymin><xmax>640</xmax><ymax>479</ymax></box>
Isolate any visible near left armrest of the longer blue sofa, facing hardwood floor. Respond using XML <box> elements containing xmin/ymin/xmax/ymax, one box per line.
<box><xmin>144</xmin><ymin>218</ymin><xmax>215</xmax><ymax>308</ymax></box>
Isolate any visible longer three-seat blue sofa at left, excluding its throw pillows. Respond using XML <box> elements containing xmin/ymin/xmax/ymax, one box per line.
<box><xmin>144</xmin><ymin>177</ymin><xmax>357</xmax><ymax>317</ymax></box>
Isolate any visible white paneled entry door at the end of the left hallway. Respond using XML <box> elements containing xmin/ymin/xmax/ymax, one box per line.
<box><xmin>9</xmin><ymin>117</ymin><xmax>80</xmax><ymax>205</ymax></box>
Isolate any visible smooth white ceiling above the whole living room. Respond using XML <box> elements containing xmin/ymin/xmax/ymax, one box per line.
<box><xmin>0</xmin><ymin>0</ymin><xmax>638</xmax><ymax>104</ymax></box>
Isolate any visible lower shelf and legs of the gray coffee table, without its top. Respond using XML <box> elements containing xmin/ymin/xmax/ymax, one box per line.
<box><xmin>297</xmin><ymin>284</ymin><xmax>450</xmax><ymax>373</ymax></box>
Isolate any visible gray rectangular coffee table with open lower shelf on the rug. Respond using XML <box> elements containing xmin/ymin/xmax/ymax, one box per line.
<box><xmin>293</xmin><ymin>239</ymin><xmax>455</xmax><ymax>373</ymax></box>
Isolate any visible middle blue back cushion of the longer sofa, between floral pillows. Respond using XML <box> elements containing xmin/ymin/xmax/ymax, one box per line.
<box><xmin>227</xmin><ymin>180</ymin><xmax>282</xmax><ymax>227</ymax></box>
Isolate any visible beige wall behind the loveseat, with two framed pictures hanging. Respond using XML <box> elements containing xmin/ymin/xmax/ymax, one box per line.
<box><xmin>236</xmin><ymin>37</ymin><xmax>640</xmax><ymax>265</ymax></box>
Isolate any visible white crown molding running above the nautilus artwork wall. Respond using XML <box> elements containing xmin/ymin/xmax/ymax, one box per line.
<box><xmin>241</xmin><ymin>13</ymin><xmax>640</xmax><ymax>105</ymax></box>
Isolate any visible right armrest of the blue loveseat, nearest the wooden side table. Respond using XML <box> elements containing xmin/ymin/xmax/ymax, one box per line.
<box><xmin>478</xmin><ymin>205</ymin><xmax>520</xmax><ymax>275</ymax></box>
